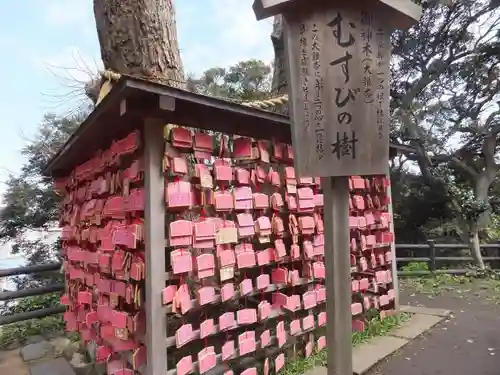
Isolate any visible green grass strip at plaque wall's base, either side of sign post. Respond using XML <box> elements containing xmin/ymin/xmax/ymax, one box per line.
<box><xmin>281</xmin><ymin>313</ymin><xmax>411</xmax><ymax>375</ymax></box>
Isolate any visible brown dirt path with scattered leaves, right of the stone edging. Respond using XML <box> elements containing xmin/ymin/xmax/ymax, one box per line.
<box><xmin>368</xmin><ymin>281</ymin><xmax>500</xmax><ymax>375</ymax></box>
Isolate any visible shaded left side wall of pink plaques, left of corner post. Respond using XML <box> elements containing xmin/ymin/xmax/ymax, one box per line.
<box><xmin>55</xmin><ymin>132</ymin><xmax>146</xmax><ymax>375</ymax></box>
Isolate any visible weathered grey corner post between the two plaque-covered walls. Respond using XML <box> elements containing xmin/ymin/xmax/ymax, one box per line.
<box><xmin>143</xmin><ymin>119</ymin><xmax>167</xmax><ymax>375</ymax></box>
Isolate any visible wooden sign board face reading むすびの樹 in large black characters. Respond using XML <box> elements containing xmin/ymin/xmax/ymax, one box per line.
<box><xmin>285</xmin><ymin>2</ymin><xmax>391</xmax><ymax>177</ymax></box>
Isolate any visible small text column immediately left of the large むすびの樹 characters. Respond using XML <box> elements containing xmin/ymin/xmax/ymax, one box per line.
<box><xmin>311</xmin><ymin>23</ymin><xmax>325</xmax><ymax>160</ymax></box>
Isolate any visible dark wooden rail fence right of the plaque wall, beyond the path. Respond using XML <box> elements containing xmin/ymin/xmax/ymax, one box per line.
<box><xmin>396</xmin><ymin>240</ymin><xmax>500</xmax><ymax>276</ymax></box>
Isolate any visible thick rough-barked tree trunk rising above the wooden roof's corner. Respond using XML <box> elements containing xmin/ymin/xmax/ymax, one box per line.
<box><xmin>94</xmin><ymin>0</ymin><xmax>185</xmax><ymax>88</ymax></box>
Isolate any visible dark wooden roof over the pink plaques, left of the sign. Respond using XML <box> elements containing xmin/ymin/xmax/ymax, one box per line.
<box><xmin>43</xmin><ymin>76</ymin><xmax>406</xmax><ymax>177</ymax></box>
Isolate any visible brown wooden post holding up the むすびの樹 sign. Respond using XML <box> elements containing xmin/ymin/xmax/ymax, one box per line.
<box><xmin>321</xmin><ymin>177</ymin><xmax>352</xmax><ymax>375</ymax></box>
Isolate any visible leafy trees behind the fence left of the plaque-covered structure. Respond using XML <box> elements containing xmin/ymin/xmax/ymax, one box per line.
<box><xmin>0</xmin><ymin>112</ymin><xmax>87</xmax><ymax>347</ymax></box>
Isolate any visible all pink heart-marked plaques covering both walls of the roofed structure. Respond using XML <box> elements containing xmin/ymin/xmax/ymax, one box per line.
<box><xmin>57</xmin><ymin>128</ymin><xmax>395</xmax><ymax>375</ymax></box>
